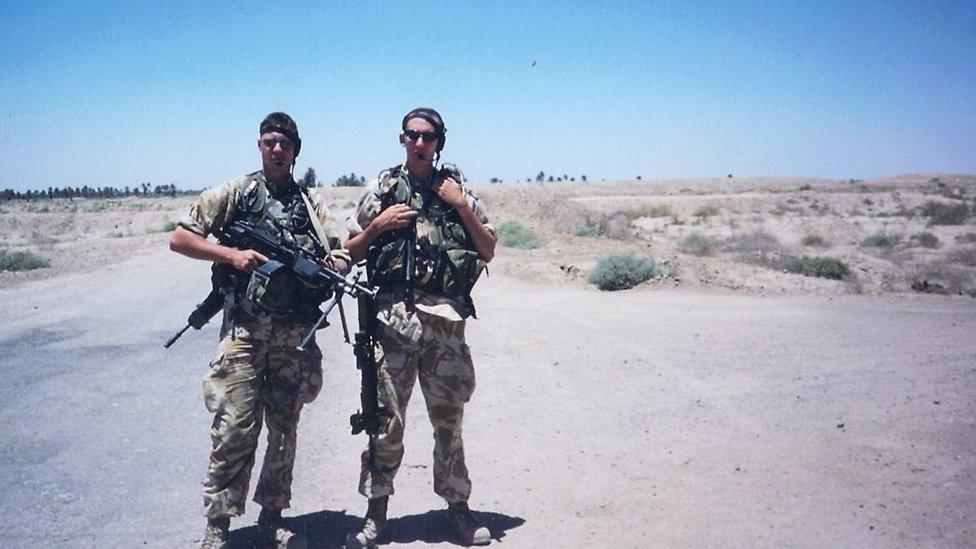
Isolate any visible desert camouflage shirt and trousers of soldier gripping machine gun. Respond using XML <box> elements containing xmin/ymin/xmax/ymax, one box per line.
<box><xmin>180</xmin><ymin>172</ymin><xmax>348</xmax><ymax>518</ymax></box>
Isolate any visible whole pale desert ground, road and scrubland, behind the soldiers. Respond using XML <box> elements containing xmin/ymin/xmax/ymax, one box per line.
<box><xmin>0</xmin><ymin>174</ymin><xmax>976</xmax><ymax>548</ymax></box>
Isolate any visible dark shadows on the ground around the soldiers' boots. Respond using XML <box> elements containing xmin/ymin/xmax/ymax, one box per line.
<box><xmin>229</xmin><ymin>509</ymin><xmax>525</xmax><ymax>549</ymax></box>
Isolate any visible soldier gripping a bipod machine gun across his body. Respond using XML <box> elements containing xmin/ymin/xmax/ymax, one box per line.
<box><xmin>170</xmin><ymin>112</ymin><xmax>348</xmax><ymax>548</ymax></box>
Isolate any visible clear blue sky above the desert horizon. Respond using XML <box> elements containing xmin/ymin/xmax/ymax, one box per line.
<box><xmin>0</xmin><ymin>0</ymin><xmax>976</xmax><ymax>189</ymax></box>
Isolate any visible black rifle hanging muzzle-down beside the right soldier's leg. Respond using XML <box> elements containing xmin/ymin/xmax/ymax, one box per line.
<box><xmin>349</xmin><ymin>282</ymin><xmax>392</xmax><ymax>469</ymax></box>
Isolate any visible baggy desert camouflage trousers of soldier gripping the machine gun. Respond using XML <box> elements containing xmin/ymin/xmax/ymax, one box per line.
<box><xmin>203</xmin><ymin>319</ymin><xmax>322</xmax><ymax>518</ymax></box>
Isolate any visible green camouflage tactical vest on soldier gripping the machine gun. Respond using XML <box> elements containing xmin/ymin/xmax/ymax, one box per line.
<box><xmin>226</xmin><ymin>172</ymin><xmax>329</xmax><ymax>315</ymax></box>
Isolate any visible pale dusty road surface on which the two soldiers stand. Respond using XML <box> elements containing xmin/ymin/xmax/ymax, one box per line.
<box><xmin>0</xmin><ymin>251</ymin><xmax>976</xmax><ymax>547</ymax></box>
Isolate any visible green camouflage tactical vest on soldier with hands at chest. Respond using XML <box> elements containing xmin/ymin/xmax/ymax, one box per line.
<box><xmin>366</xmin><ymin>166</ymin><xmax>485</xmax><ymax>312</ymax></box>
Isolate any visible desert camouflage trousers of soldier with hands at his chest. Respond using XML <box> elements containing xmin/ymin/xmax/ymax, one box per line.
<box><xmin>359</xmin><ymin>311</ymin><xmax>475</xmax><ymax>502</ymax></box>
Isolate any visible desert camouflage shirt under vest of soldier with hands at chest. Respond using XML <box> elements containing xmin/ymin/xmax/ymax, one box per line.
<box><xmin>346</xmin><ymin>167</ymin><xmax>495</xmax><ymax>323</ymax></box>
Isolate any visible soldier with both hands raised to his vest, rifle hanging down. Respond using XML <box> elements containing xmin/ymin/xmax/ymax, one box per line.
<box><xmin>346</xmin><ymin>108</ymin><xmax>496</xmax><ymax>548</ymax></box>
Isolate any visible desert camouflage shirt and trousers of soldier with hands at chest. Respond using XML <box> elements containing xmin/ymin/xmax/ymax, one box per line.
<box><xmin>348</xmin><ymin>166</ymin><xmax>495</xmax><ymax>503</ymax></box>
